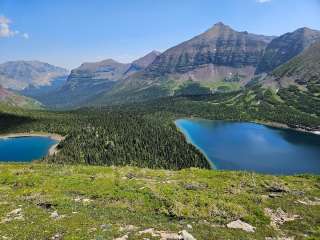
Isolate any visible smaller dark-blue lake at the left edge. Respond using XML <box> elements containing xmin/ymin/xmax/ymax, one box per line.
<box><xmin>0</xmin><ymin>137</ymin><xmax>57</xmax><ymax>162</ymax></box>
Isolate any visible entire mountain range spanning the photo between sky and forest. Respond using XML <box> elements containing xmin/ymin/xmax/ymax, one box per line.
<box><xmin>0</xmin><ymin>22</ymin><xmax>320</xmax><ymax>108</ymax></box>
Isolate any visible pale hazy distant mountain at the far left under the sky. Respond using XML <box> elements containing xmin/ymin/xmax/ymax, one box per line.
<box><xmin>0</xmin><ymin>61</ymin><xmax>68</xmax><ymax>91</ymax></box>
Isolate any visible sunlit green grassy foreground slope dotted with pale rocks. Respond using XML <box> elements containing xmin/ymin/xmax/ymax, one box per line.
<box><xmin>0</xmin><ymin>164</ymin><xmax>320</xmax><ymax>240</ymax></box>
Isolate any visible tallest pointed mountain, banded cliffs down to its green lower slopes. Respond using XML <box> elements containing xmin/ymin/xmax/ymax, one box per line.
<box><xmin>94</xmin><ymin>23</ymin><xmax>273</xmax><ymax>104</ymax></box>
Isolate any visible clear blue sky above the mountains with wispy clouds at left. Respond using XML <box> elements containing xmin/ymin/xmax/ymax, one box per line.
<box><xmin>0</xmin><ymin>0</ymin><xmax>320</xmax><ymax>69</ymax></box>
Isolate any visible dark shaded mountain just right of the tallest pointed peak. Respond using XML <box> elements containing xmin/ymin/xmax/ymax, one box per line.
<box><xmin>256</xmin><ymin>28</ymin><xmax>320</xmax><ymax>74</ymax></box>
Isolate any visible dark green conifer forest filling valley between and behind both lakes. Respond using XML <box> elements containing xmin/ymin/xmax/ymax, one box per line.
<box><xmin>0</xmin><ymin>84</ymin><xmax>320</xmax><ymax>169</ymax></box>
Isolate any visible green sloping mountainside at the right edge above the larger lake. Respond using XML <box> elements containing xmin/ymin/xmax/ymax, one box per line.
<box><xmin>262</xmin><ymin>42</ymin><xmax>320</xmax><ymax>116</ymax></box>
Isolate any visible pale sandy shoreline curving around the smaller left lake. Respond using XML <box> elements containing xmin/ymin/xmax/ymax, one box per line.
<box><xmin>0</xmin><ymin>132</ymin><xmax>65</xmax><ymax>156</ymax></box>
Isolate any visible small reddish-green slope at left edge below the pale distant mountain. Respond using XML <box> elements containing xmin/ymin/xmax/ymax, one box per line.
<box><xmin>0</xmin><ymin>85</ymin><xmax>41</xmax><ymax>108</ymax></box>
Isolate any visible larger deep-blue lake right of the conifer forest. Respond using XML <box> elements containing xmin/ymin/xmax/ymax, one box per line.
<box><xmin>176</xmin><ymin>119</ymin><xmax>320</xmax><ymax>175</ymax></box>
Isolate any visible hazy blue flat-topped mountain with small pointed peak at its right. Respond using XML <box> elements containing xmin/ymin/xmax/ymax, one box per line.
<box><xmin>37</xmin><ymin>51</ymin><xmax>159</xmax><ymax>108</ymax></box>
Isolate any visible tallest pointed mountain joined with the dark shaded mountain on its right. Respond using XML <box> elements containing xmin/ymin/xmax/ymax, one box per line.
<box><xmin>92</xmin><ymin>23</ymin><xmax>320</xmax><ymax>105</ymax></box>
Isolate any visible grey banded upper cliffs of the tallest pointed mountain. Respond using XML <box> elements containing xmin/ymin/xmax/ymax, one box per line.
<box><xmin>145</xmin><ymin>23</ymin><xmax>271</xmax><ymax>77</ymax></box>
